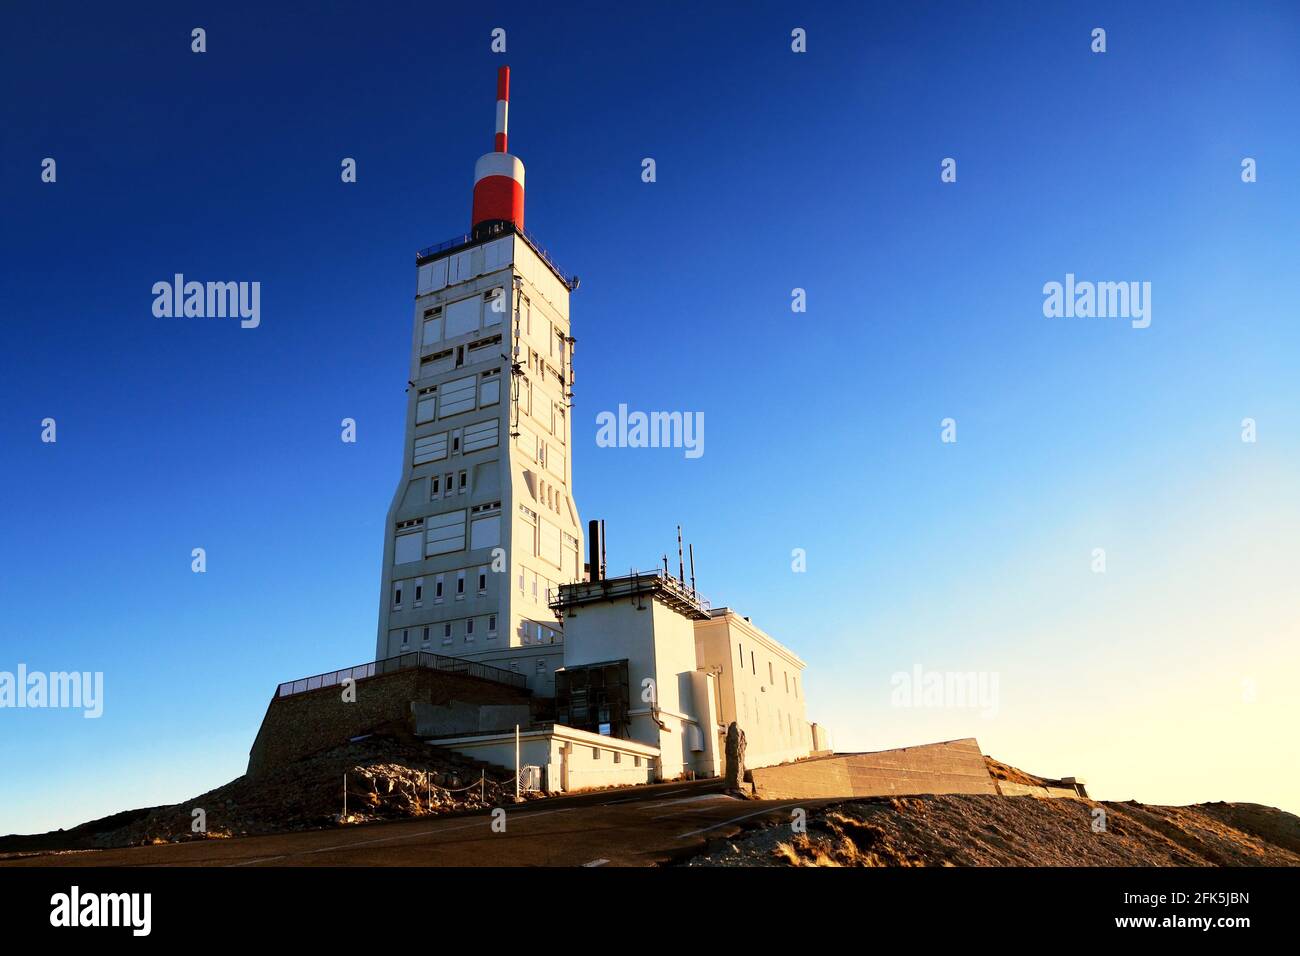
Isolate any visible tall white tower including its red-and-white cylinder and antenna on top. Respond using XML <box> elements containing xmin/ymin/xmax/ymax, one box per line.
<box><xmin>376</xmin><ymin>68</ymin><xmax>585</xmax><ymax>695</ymax></box>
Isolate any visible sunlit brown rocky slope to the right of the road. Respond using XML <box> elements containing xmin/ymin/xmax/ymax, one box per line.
<box><xmin>686</xmin><ymin>790</ymin><xmax>1300</xmax><ymax>866</ymax></box>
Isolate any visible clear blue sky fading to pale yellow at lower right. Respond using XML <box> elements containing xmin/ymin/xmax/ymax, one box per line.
<box><xmin>0</xmin><ymin>1</ymin><xmax>1300</xmax><ymax>834</ymax></box>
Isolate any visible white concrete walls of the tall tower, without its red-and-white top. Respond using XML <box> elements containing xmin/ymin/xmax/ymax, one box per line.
<box><xmin>374</xmin><ymin>235</ymin><xmax>584</xmax><ymax>695</ymax></box>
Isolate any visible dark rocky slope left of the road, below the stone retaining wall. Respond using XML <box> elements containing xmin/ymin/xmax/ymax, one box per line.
<box><xmin>0</xmin><ymin>736</ymin><xmax>530</xmax><ymax>856</ymax></box>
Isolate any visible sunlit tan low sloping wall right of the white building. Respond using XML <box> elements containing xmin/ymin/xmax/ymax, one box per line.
<box><xmin>750</xmin><ymin>737</ymin><xmax>998</xmax><ymax>800</ymax></box>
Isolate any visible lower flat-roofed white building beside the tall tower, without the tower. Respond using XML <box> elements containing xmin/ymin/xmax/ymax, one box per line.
<box><xmin>436</xmin><ymin>571</ymin><xmax>819</xmax><ymax>791</ymax></box>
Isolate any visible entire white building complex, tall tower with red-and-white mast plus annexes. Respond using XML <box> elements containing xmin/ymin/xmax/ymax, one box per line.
<box><xmin>376</xmin><ymin>68</ymin><xmax>815</xmax><ymax>790</ymax></box>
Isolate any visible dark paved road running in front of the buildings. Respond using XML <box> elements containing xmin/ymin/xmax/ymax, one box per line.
<box><xmin>0</xmin><ymin>780</ymin><xmax>819</xmax><ymax>866</ymax></box>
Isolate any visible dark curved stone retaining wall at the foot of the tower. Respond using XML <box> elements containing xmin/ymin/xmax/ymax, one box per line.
<box><xmin>247</xmin><ymin>667</ymin><xmax>538</xmax><ymax>777</ymax></box>
